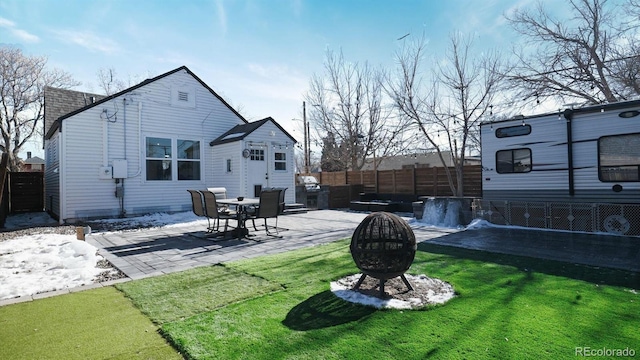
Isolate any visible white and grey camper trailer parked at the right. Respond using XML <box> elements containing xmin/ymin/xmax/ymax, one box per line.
<box><xmin>479</xmin><ymin>101</ymin><xmax>640</xmax><ymax>235</ymax></box>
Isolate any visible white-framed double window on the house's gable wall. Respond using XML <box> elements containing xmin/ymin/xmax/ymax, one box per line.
<box><xmin>145</xmin><ymin>137</ymin><xmax>201</xmax><ymax>181</ymax></box>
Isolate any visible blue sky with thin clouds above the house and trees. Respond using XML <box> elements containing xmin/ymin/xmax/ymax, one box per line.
<box><xmin>0</xmin><ymin>0</ymin><xmax>533</xmax><ymax>157</ymax></box>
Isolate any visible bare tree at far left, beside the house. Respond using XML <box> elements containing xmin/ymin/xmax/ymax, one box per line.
<box><xmin>0</xmin><ymin>47</ymin><xmax>80</xmax><ymax>171</ymax></box>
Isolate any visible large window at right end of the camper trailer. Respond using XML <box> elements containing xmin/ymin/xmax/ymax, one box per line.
<box><xmin>598</xmin><ymin>134</ymin><xmax>640</xmax><ymax>182</ymax></box>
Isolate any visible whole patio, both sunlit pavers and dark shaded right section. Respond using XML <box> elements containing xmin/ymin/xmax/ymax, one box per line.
<box><xmin>86</xmin><ymin>210</ymin><xmax>640</xmax><ymax>279</ymax></box>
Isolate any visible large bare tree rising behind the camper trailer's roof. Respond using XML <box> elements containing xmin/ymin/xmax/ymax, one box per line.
<box><xmin>505</xmin><ymin>0</ymin><xmax>640</xmax><ymax>104</ymax></box>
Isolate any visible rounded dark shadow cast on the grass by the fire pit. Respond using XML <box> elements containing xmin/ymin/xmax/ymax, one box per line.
<box><xmin>282</xmin><ymin>290</ymin><xmax>376</xmax><ymax>331</ymax></box>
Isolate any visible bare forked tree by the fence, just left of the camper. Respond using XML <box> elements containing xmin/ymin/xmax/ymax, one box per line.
<box><xmin>387</xmin><ymin>35</ymin><xmax>504</xmax><ymax>196</ymax></box>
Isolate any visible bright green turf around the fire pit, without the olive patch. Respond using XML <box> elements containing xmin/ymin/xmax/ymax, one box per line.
<box><xmin>114</xmin><ymin>241</ymin><xmax>640</xmax><ymax>359</ymax></box>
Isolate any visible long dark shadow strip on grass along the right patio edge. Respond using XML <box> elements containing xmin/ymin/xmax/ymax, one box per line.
<box><xmin>418</xmin><ymin>242</ymin><xmax>640</xmax><ymax>289</ymax></box>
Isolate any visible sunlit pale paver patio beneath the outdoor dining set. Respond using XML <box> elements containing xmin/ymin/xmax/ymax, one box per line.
<box><xmin>86</xmin><ymin>210</ymin><xmax>457</xmax><ymax>279</ymax></box>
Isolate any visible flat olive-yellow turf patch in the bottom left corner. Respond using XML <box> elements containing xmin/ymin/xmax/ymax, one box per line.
<box><xmin>0</xmin><ymin>287</ymin><xmax>182</xmax><ymax>359</ymax></box>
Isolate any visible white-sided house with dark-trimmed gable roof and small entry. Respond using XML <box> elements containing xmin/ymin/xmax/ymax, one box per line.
<box><xmin>45</xmin><ymin>66</ymin><xmax>295</xmax><ymax>223</ymax></box>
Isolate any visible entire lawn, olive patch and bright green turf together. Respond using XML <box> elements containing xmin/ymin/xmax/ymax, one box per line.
<box><xmin>0</xmin><ymin>241</ymin><xmax>640</xmax><ymax>359</ymax></box>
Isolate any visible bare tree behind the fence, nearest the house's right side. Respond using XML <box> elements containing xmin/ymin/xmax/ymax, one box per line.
<box><xmin>306</xmin><ymin>51</ymin><xmax>402</xmax><ymax>170</ymax></box>
